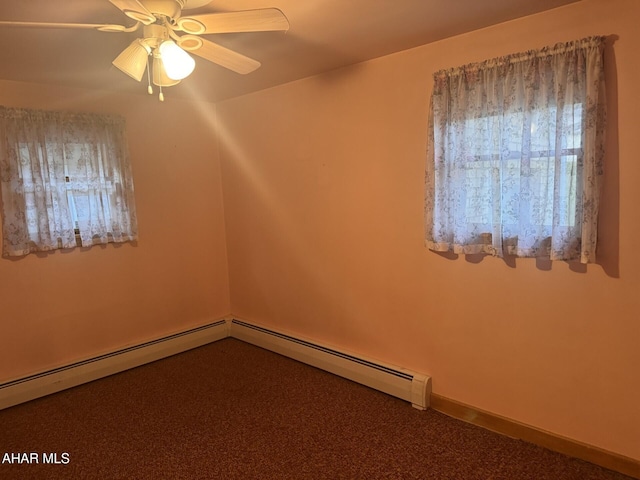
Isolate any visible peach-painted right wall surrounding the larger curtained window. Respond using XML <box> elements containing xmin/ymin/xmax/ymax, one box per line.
<box><xmin>217</xmin><ymin>0</ymin><xmax>640</xmax><ymax>459</ymax></box>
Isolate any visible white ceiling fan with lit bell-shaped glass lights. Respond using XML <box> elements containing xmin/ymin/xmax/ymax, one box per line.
<box><xmin>0</xmin><ymin>0</ymin><xmax>289</xmax><ymax>101</ymax></box>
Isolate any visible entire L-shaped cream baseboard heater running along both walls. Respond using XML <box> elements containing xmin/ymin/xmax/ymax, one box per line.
<box><xmin>0</xmin><ymin>319</ymin><xmax>431</xmax><ymax>410</ymax></box>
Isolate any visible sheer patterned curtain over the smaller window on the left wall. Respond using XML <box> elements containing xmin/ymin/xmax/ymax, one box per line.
<box><xmin>0</xmin><ymin>107</ymin><xmax>137</xmax><ymax>256</ymax></box>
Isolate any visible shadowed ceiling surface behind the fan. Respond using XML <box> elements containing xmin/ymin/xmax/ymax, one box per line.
<box><xmin>0</xmin><ymin>0</ymin><xmax>579</xmax><ymax>101</ymax></box>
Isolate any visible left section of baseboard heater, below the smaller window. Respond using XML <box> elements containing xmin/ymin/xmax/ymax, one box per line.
<box><xmin>0</xmin><ymin>320</ymin><xmax>229</xmax><ymax>410</ymax></box>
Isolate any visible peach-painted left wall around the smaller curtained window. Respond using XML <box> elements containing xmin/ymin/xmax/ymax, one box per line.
<box><xmin>0</xmin><ymin>81</ymin><xmax>230</xmax><ymax>383</ymax></box>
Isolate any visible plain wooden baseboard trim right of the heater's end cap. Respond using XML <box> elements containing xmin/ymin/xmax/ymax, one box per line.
<box><xmin>431</xmin><ymin>393</ymin><xmax>640</xmax><ymax>479</ymax></box>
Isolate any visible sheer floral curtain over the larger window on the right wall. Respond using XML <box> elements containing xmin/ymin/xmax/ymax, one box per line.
<box><xmin>425</xmin><ymin>37</ymin><xmax>606</xmax><ymax>263</ymax></box>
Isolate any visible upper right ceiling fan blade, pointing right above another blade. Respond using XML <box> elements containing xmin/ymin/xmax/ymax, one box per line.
<box><xmin>177</xmin><ymin>8</ymin><xmax>289</xmax><ymax>35</ymax></box>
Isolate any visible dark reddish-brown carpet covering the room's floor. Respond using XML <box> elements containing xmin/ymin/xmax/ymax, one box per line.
<box><xmin>0</xmin><ymin>339</ymin><xmax>629</xmax><ymax>480</ymax></box>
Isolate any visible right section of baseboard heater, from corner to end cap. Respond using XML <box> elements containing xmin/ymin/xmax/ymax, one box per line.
<box><xmin>231</xmin><ymin>319</ymin><xmax>431</xmax><ymax>410</ymax></box>
